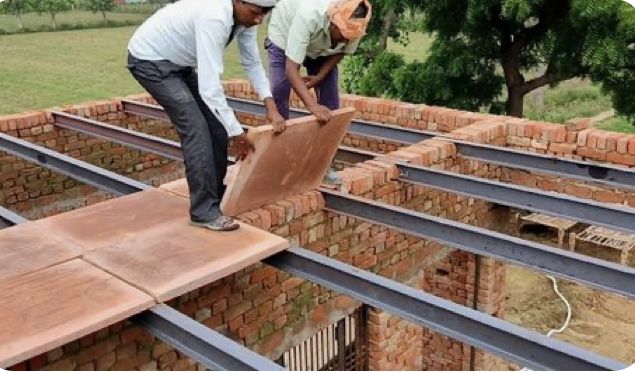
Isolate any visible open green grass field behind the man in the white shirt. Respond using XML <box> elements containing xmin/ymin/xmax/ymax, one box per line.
<box><xmin>0</xmin><ymin>27</ymin><xmax>262</xmax><ymax>114</ymax></box>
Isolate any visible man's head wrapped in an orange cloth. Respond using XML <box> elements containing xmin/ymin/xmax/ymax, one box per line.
<box><xmin>328</xmin><ymin>0</ymin><xmax>373</xmax><ymax>43</ymax></box>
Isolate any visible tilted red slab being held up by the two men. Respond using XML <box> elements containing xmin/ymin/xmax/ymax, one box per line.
<box><xmin>221</xmin><ymin>108</ymin><xmax>355</xmax><ymax>216</ymax></box>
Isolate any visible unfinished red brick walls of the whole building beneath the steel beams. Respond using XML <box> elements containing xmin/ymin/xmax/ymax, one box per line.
<box><xmin>0</xmin><ymin>81</ymin><xmax>634</xmax><ymax>370</ymax></box>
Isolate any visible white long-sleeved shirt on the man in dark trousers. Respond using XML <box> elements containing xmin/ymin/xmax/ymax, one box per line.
<box><xmin>128</xmin><ymin>0</ymin><xmax>272</xmax><ymax>137</ymax></box>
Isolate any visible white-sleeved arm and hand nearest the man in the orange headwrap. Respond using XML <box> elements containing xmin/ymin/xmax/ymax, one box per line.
<box><xmin>237</xmin><ymin>26</ymin><xmax>286</xmax><ymax>134</ymax></box>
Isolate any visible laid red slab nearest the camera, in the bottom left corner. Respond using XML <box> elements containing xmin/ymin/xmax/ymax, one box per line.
<box><xmin>0</xmin><ymin>259</ymin><xmax>155</xmax><ymax>367</ymax></box>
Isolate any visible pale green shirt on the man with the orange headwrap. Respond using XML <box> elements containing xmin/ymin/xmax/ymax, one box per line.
<box><xmin>268</xmin><ymin>0</ymin><xmax>360</xmax><ymax>65</ymax></box>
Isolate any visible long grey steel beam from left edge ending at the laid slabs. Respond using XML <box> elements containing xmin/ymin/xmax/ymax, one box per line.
<box><xmin>0</xmin><ymin>133</ymin><xmax>151</xmax><ymax>195</ymax></box>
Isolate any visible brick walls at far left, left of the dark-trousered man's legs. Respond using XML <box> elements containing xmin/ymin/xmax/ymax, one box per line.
<box><xmin>0</xmin><ymin>100</ymin><xmax>183</xmax><ymax>219</ymax></box>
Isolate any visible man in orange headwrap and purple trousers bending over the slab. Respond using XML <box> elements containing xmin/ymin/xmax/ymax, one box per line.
<box><xmin>265</xmin><ymin>0</ymin><xmax>372</xmax><ymax>126</ymax></box>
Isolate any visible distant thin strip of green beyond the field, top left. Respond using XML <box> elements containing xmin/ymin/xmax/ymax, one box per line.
<box><xmin>0</xmin><ymin>10</ymin><xmax>148</xmax><ymax>32</ymax></box>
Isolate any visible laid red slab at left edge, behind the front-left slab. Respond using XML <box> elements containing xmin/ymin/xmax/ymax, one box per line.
<box><xmin>0</xmin><ymin>220</ymin><xmax>82</xmax><ymax>280</ymax></box>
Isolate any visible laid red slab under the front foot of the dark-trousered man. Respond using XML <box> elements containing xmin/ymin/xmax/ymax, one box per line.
<box><xmin>84</xmin><ymin>219</ymin><xmax>289</xmax><ymax>302</ymax></box>
